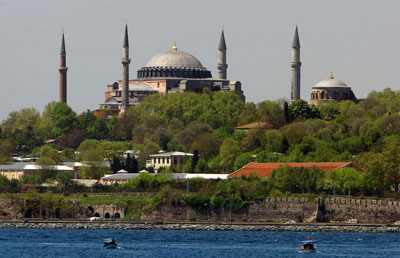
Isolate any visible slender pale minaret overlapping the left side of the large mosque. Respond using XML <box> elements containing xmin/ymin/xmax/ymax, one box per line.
<box><xmin>121</xmin><ymin>24</ymin><xmax>131</xmax><ymax>113</ymax></box>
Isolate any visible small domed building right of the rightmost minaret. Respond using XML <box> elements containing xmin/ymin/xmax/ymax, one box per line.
<box><xmin>310</xmin><ymin>73</ymin><xmax>358</xmax><ymax>104</ymax></box>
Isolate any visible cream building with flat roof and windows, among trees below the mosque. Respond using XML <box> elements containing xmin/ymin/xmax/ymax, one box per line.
<box><xmin>146</xmin><ymin>151</ymin><xmax>193</xmax><ymax>172</ymax></box>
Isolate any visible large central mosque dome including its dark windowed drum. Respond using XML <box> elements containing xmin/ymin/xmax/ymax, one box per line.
<box><xmin>137</xmin><ymin>42</ymin><xmax>212</xmax><ymax>78</ymax></box>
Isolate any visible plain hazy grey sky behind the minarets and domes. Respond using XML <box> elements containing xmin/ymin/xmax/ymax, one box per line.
<box><xmin>0</xmin><ymin>0</ymin><xmax>400</xmax><ymax>121</ymax></box>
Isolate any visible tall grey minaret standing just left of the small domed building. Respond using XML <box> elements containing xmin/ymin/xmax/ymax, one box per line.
<box><xmin>290</xmin><ymin>25</ymin><xmax>301</xmax><ymax>102</ymax></box>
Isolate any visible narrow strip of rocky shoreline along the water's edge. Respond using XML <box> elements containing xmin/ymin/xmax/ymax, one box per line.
<box><xmin>0</xmin><ymin>221</ymin><xmax>400</xmax><ymax>233</ymax></box>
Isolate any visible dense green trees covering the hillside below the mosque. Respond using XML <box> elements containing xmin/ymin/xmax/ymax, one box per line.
<box><xmin>0</xmin><ymin>89</ymin><xmax>400</xmax><ymax>198</ymax></box>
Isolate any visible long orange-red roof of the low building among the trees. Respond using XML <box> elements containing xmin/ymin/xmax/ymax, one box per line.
<box><xmin>228</xmin><ymin>162</ymin><xmax>362</xmax><ymax>178</ymax></box>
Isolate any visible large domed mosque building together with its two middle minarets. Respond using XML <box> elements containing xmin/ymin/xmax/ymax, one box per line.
<box><xmin>96</xmin><ymin>27</ymin><xmax>245</xmax><ymax>115</ymax></box>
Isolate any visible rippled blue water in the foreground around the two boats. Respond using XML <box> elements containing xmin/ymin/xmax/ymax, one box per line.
<box><xmin>0</xmin><ymin>229</ymin><xmax>400</xmax><ymax>258</ymax></box>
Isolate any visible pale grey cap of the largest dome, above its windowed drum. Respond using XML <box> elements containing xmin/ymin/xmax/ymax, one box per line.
<box><xmin>146</xmin><ymin>49</ymin><xmax>204</xmax><ymax>68</ymax></box>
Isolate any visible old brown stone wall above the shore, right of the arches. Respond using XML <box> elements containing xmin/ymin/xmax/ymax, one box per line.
<box><xmin>142</xmin><ymin>197</ymin><xmax>400</xmax><ymax>223</ymax></box>
